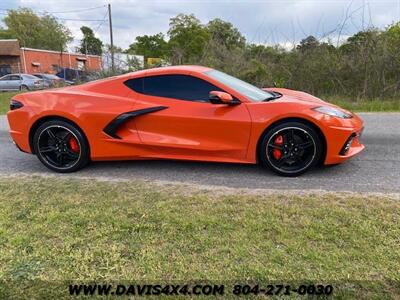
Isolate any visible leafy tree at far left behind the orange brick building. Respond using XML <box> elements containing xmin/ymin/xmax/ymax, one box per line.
<box><xmin>0</xmin><ymin>8</ymin><xmax>72</xmax><ymax>51</ymax></box>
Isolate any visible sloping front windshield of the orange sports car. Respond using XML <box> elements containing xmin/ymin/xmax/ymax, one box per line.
<box><xmin>205</xmin><ymin>70</ymin><xmax>274</xmax><ymax>102</ymax></box>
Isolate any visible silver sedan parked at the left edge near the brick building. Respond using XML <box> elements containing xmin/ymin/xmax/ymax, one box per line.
<box><xmin>0</xmin><ymin>74</ymin><xmax>47</xmax><ymax>91</ymax></box>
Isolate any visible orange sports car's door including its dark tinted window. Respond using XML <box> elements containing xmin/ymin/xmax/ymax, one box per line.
<box><xmin>128</xmin><ymin>74</ymin><xmax>251</xmax><ymax>161</ymax></box>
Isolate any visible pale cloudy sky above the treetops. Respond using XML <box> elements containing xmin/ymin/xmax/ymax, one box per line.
<box><xmin>0</xmin><ymin>0</ymin><xmax>400</xmax><ymax>50</ymax></box>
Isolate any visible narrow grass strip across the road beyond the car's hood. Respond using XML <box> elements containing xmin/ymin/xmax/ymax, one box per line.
<box><xmin>322</xmin><ymin>96</ymin><xmax>400</xmax><ymax>112</ymax></box>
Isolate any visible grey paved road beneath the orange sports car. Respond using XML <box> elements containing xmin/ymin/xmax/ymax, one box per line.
<box><xmin>0</xmin><ymin>113</ymin><xmax>400</xmax><ymax>193</ymax></box>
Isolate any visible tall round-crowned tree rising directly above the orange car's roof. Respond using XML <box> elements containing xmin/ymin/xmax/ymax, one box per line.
<box><xmin>168</xmin><ymin>14</ymin><xmax>210</xmax><ymax>64</ymax></box>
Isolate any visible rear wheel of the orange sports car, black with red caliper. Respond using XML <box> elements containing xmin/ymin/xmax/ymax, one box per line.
<box><xmin>33</xmin><ymin>120</ymin><xmax>90</xmax><ymax>173</ymax></box>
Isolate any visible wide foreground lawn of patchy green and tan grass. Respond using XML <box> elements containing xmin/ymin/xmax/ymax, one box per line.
<box><xmin>0</xmin><ymin>178</ymin><xmax>400</xmax><ymax>299</ymax></box>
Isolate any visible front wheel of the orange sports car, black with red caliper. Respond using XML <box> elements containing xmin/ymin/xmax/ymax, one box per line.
<box><xmin>258</xmin><ymin>121</ymin><xmax>322</xmax><ymax>177</ymax></box>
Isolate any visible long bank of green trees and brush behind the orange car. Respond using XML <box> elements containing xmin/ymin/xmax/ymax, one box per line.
<box><xmin>108</xmin><ymin>14</ymin><xmax>400</xmax><ymax>99</ymax></box>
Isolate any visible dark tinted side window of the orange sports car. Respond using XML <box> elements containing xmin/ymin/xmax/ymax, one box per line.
<box><xmin>125</xmin><ymin>75</ymin><xmax>221</xmax><ymax>102</ymax></box>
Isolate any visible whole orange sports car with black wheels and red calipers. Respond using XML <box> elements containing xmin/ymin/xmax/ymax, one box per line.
<box><xmin>7</xmin><ymin>66</ymin><xmax>364</xmax><ymax>176</ymax></box>
